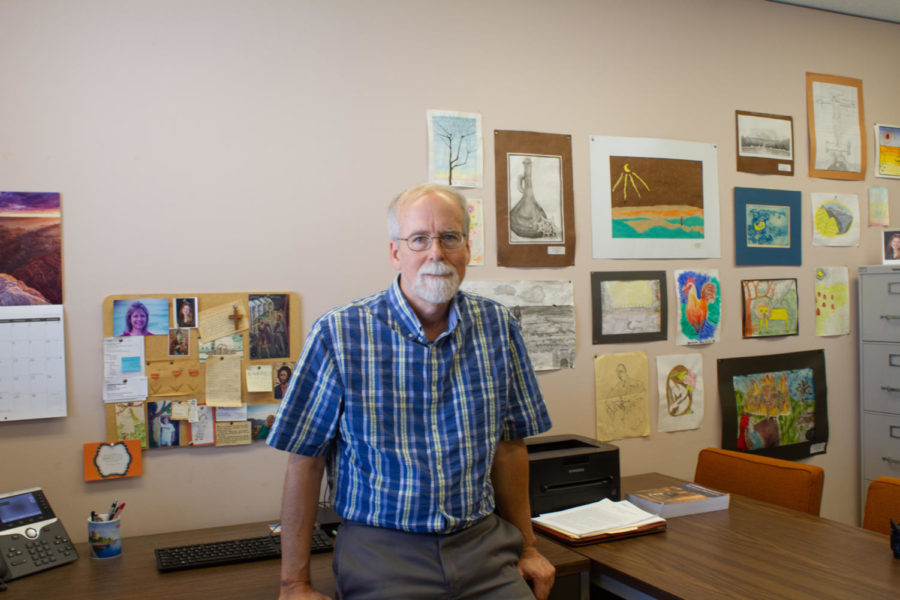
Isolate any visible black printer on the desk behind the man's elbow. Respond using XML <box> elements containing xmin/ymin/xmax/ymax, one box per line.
<box><xmin>525</xmin><ymin>435</ymin><xmax>620</xmax><ymax>517</ymax></box>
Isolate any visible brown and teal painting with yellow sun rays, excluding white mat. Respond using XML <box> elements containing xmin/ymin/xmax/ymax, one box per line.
<box><xmin>609</xmin><ymin>156</ymin><xmax>704</xmax><ymax>239</ymax></box>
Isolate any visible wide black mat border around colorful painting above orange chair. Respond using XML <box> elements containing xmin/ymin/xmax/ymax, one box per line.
<box><xmin>716</xmin><ymin>349</ymin><xmax>828</xmax><ymax>460</ymax></box>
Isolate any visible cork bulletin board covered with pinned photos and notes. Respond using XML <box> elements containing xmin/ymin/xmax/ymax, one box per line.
<box><xmin>103</xmin><ymin>292</ymin><xmax>303</xmax><ymax>449</ymax></box>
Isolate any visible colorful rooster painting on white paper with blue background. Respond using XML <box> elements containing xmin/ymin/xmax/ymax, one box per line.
<box><xmin>675</xmin><ymin>269</ymin><xmax>721</xmax><ymax>346</ymax></box>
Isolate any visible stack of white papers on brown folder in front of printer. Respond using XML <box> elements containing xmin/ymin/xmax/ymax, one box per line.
<box><xmin>531</xmin><ymin>498</ymin><xmax>666</xmax><ymax>545</ymax></box>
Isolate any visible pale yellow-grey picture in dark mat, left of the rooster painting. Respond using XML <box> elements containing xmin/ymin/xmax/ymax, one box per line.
<box><xmin>591</xmin><ymin>271</ymin><xmax>668</xmax><ymax>344</ymax></box>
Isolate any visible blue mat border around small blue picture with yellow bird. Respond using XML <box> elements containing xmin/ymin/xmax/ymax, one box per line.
<box><xmin>734</xmin><ymin>187</ymin><xmax>803</xmax><ymax>266</ymax></box>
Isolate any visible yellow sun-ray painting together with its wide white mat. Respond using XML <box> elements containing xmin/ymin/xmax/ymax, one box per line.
<box><xmin>591</xmin><ymin>136</ymin><xmax>720</xmax><ymax>258</ymax></box>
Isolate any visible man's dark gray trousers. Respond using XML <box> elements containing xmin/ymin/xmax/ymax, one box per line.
<box><xmin>333</xmin><ymin>515</ymin><xmax>534</xmax><ymax>600</ymax></box>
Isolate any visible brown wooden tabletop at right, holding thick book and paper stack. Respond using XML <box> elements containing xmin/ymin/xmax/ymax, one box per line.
<box><xmin>576</xmin><ymin>473</ymin><xmax>900</xmax><ymax>600</ymax></box>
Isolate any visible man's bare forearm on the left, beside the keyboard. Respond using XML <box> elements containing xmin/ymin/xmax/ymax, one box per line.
<box><xmin>281</xmin><ymin>454</ymin><xmax>325</xmax><ymax>588</ymax></box>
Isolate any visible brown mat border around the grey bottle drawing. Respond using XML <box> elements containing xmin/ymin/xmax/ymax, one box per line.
<box><xmin>494</xmin><ymin>130</ymin><xmax>575</xmax><ymax>267</ymax></box>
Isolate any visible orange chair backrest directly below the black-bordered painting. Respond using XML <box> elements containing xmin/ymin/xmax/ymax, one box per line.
<box><xmin>694</xmin><ymin>448</ymin><xmax>825</xmax><ymax>515</ymax></box>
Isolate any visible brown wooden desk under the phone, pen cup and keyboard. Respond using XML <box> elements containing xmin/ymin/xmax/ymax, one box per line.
<box><xmin>0</xmin><ymin>523</ymin><xmax>590</xmax><ymax>600</ymax></box>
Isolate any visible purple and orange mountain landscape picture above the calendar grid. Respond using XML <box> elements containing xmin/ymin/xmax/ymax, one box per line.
<box><xmin>0</xmin><ymin>192</ymin><xmax>62</xmax><ymax>306</ymax></box>
